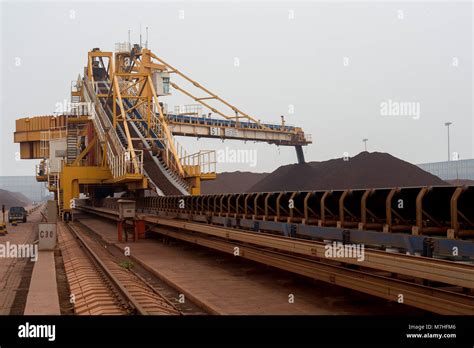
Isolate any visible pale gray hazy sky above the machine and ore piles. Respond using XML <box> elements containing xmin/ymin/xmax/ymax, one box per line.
<box><xmin>0</xmin><ymin>1</ymin><xmax>474</xmax><ymax>175</ymax></box>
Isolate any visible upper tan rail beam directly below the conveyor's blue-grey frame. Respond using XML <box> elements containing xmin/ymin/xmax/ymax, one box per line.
<box><xmin>80</xmin><ymin>206</ymin><xmax>474</xmax><ymax>288</ymax></box>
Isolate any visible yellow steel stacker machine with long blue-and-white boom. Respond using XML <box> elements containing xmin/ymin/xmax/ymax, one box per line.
<box><xmin>15</xmin><ymin>43</ymin><xmax>311</xmax><ymax>219</ymax></box>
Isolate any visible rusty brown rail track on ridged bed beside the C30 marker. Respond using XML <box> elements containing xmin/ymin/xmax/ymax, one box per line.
<box><xmin>59</xmin><ymin>223</ymin><xmax>181</xmax><ymax>315</ymax></box>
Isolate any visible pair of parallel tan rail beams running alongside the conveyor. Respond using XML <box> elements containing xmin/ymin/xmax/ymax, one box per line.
<box><xmin>77</xmin><ymin>208</ymin><xmax>474</xmax><ymax>315</ymax></box>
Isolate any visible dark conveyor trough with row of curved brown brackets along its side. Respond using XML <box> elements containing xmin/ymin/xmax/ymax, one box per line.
<box><xmin>132</xmin><ymin>186</ymin><xmax>474</xmax><ymax>239</ymax></box>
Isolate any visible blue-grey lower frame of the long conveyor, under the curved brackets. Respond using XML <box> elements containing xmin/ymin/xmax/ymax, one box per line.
<box><xmin>79</xmin><ymin>194</ymin><xmax>474</xmax><ymax>262</ymax></box>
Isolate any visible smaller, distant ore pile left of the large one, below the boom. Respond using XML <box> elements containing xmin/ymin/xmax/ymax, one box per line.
<box><xmin>201</xmin><ymin>172</ymin><xmax>269</xmax><ymax>194</ymax></box>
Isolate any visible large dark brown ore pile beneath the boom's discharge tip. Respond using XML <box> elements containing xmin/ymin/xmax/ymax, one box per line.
<box><xmin>249</xmin><ymin>152</ymin><xmax>449</xmax><ymax>192</ymax></box>
